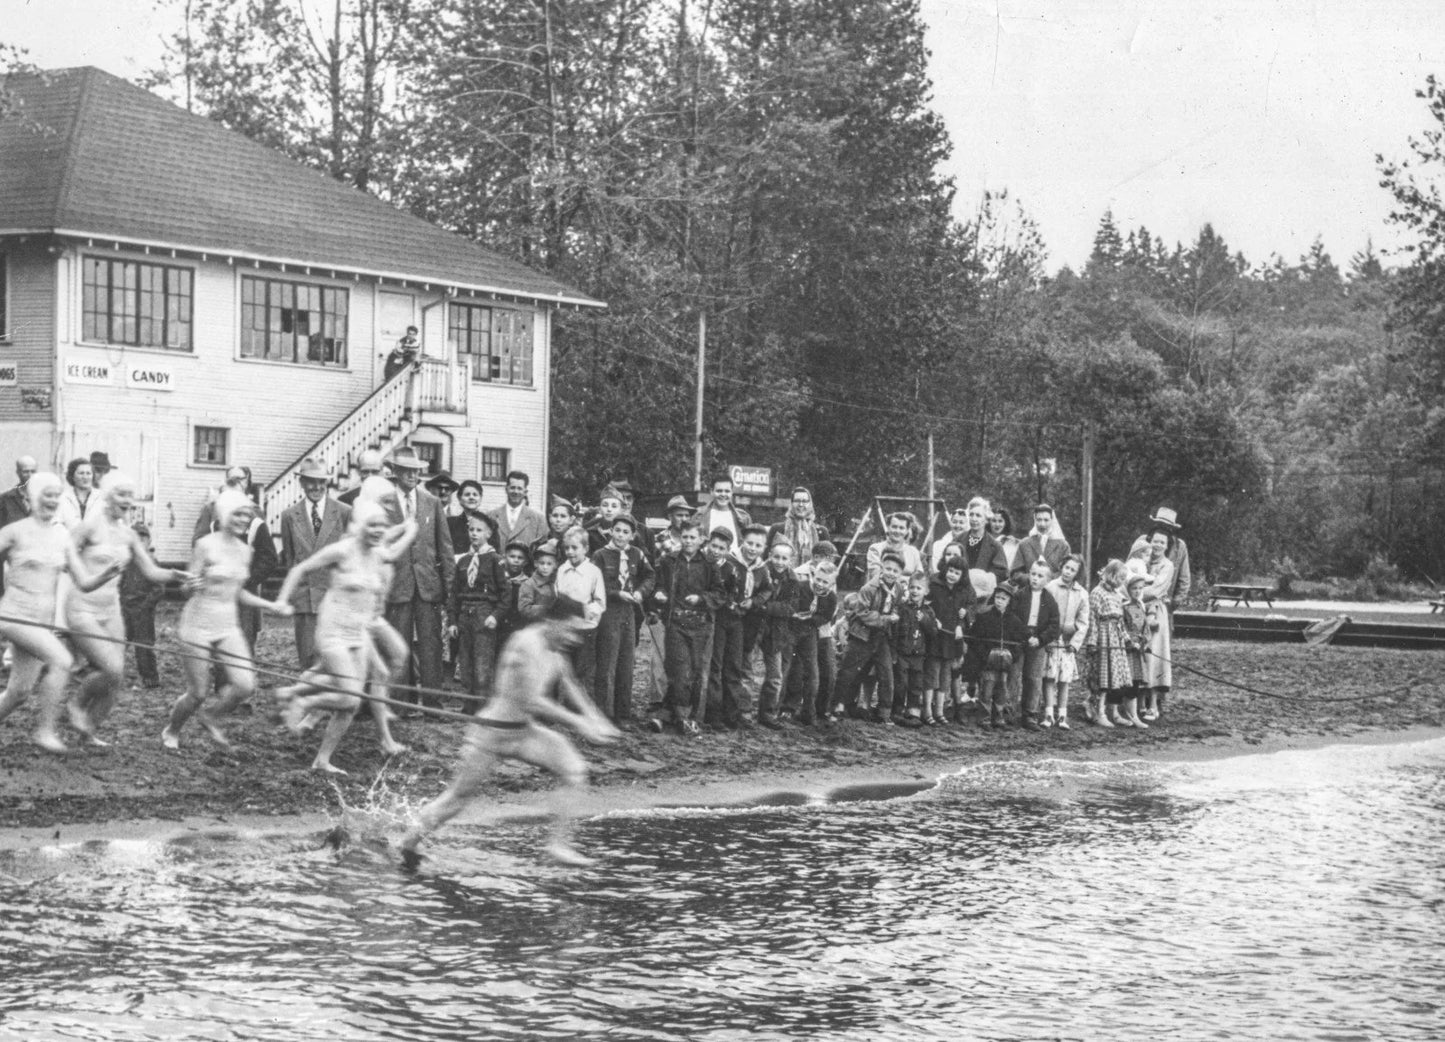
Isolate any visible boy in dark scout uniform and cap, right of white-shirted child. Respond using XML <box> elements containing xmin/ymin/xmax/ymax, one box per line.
<box><xmin>592</xmin><ymin>513</ymin><xmax>656</xmax><ymax>727</ymax></box>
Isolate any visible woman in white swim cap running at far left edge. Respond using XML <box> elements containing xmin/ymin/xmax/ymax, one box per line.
<box><xmin>0</xmin><ymin>473</ymin><xmax>121</xmax><ymax>753</ymax></box>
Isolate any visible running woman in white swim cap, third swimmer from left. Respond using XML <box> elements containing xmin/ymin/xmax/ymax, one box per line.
<box><xmin>160</xmin><ymin>488</ymin><xmax>280</xmax><ymax>749</ymax></box>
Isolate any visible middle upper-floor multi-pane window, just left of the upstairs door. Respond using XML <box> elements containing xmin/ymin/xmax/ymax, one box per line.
<box><xmin>241</xmin><ymin>275</ymin><xmax>348</xmax><ymax>366</ymax></box>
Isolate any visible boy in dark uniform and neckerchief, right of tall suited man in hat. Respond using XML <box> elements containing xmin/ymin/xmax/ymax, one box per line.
<box><xmin>447</xmin><ymin>514</ymin><xmax>512</xmax><ymax>710</ymax></box>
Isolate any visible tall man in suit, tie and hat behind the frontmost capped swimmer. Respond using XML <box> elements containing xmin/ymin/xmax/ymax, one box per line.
<box><xmin>386</xmin><ymin>448</ymin><xmax>455</xmax><ymax>705</ymax></box>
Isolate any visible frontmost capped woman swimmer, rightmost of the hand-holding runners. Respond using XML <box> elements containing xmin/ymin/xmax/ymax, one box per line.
<box><xmin>276</xmin><ymin>497</ymin><xmax>416</xmax><ymax>775</ymax></box>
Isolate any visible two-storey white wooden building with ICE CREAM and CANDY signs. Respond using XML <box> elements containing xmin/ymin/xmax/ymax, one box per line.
<box><xmin>0</xmin><ymin>68</ymin><xmax>603</xmax><ymax>561</ymax></box>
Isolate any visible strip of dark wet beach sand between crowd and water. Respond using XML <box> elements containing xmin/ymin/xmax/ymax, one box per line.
<box><xmin>0</xmin><ymin>606</ymin><xmax>1445</xmax><ymax>845</ymax></box>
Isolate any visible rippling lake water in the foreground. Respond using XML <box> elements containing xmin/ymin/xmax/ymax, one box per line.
<box><xmin>0</xmin><ymin>740</ymin><xmax>1445</xmax><ymax>1042</ymax></box>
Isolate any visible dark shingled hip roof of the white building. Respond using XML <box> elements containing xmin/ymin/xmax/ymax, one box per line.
<box><xmin>0</xmin><ymin>68</ymin><xmax>603</xmax><ymax>306</ymax></box>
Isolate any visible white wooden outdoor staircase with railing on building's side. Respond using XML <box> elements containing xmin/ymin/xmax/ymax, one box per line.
<box><xmin>260</xmin><ymin>357</ymin><xmax>471</xmax><ymax>535</ymax></box>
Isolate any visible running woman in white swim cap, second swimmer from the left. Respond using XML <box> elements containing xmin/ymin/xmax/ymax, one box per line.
<box><xmin>65</xmin><ymin>471</ymin><xmax>191</xmax><ymax>746</ymax></box>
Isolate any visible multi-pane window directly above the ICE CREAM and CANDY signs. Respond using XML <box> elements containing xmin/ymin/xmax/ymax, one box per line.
<box><xmin>81</xmin><ymin>257</ymin><xmax>194</xmax><ymax>351</ymax></box>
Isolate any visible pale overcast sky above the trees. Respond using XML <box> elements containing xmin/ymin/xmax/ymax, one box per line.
<box><xmin>0</xmin><ymin>0</ymin><xmax>1445</xmax><ymax>267</ymax></box>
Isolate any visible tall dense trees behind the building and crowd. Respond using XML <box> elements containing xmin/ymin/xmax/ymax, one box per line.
<box><xmin>5</xmin><ymin>0</ymin><xmax>1445</xmax><ymax>592</ymax></box>
